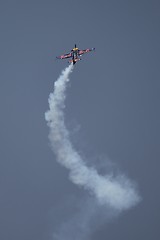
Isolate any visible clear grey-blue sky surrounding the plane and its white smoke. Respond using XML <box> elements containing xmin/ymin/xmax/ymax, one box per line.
<box><xmin>0</xmin><ymin>0</ymin><xmax>160</xmax><ymax>240</ymax></box>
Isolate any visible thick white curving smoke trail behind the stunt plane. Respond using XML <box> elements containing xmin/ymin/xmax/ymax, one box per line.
<box><xmin>45</xmin><ymin>65</ymin><xmax>140</xmax><ymax>211</ymax></box>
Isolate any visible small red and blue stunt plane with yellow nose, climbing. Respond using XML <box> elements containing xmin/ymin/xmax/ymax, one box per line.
<box><xmin>56</xmin><ymin>44</ymin><xmax>95</xmax><ymax>65</ymax></box>
